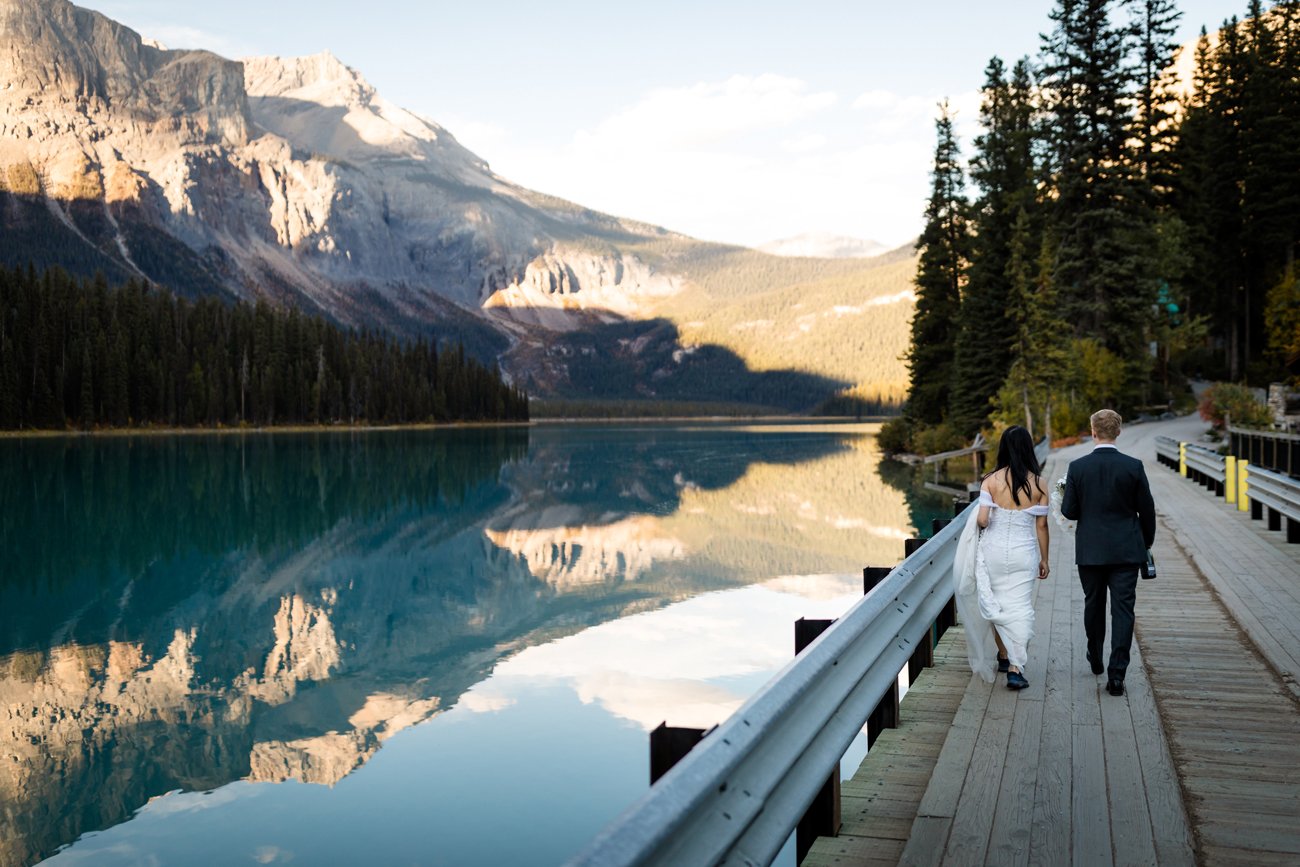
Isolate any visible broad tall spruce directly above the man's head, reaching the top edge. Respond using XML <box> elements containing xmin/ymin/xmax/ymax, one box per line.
<box><xmin>1043</xmin><ymin>0</ymin><xmax>1158</xmax><ymax>400</ymax></box>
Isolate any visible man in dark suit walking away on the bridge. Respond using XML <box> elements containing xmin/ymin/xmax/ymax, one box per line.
<box><xmin>1061</xmin><ymin>409</ymin><xmax>1156</xmax><ymax>695</ymax></box>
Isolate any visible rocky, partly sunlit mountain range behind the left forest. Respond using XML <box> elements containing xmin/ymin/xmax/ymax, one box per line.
<box><xmin>0</xmin><ymin>0</ymin><xmax>910</xmax><ymax>408</ymax></box>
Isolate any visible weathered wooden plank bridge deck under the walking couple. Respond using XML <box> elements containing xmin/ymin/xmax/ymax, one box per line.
<box><xmin>805</xmin><ymin>422</ymin><xmax>1300</xmax><ymax>866</ymax></box>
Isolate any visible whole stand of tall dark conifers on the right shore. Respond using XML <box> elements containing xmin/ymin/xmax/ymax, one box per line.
<box><xmin>887</xmin><ymin>0</ymin><xmax>1300</xmax><ymax>451</ymax></box>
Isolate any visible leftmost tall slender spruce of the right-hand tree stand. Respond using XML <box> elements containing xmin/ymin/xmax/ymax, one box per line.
<box><xmin>907</xmin><ymin>101</ymin><xmax>970</xmax><ymax>425</ymax></box>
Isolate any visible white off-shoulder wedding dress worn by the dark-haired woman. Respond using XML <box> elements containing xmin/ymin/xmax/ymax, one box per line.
<box><xmin>953</xmin><ymin>491</ymin><xmax>1048</xmax><ymax>682</ymax></box>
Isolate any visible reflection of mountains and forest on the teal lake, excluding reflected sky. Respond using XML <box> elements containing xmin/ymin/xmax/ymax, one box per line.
<box><xmin>0</xmin><ymin>426</ymin><xmax>946</xmax><ymax>867</ymax></box>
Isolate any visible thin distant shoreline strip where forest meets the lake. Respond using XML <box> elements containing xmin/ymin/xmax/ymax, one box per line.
<box><xmin>0</xmin><ymin>416</ymin><xmax>892</xmax><ymax>439</ymax></box>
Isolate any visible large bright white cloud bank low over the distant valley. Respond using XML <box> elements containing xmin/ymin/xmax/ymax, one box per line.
<box><xmin>467</xmin><ymin>74</ymin><xmax>979</xmax><ymax>246</ymax></box>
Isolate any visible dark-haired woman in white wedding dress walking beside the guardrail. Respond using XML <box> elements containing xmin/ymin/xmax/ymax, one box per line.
<box><xmin>953</xmin><ymin>426</ymin><xmax>1049</xmax><ymax>689</ymax></box>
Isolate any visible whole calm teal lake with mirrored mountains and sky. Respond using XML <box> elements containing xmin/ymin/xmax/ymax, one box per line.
<box><xmin>0</xmin><ymin>424</ymin><xmax>950</xmax><ymax>867</ymax></box>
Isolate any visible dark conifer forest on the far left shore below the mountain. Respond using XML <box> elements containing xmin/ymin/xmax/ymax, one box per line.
<box><xmin>0</xmin><ymin>266</ymin><xmax>528</xmax><ymax>429</ymax></box>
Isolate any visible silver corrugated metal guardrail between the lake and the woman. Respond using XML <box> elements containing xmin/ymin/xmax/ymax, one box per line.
<box><xmin>569</xmin><ymin>508</ymin><xmax>975</xmax><ymax>867</ymax></box>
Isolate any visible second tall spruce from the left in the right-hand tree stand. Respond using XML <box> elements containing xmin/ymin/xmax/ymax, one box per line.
<box><xmin>952</xmin><ymin>57</ymin><xmax>1036</xmax><ymax>435</ymax></box>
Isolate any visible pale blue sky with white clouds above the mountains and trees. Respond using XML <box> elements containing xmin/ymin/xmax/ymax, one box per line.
<box><xmin>91</xmin><ymin>0</ymin><xmax>1247</xmax><ymax>246</ymax></box>
